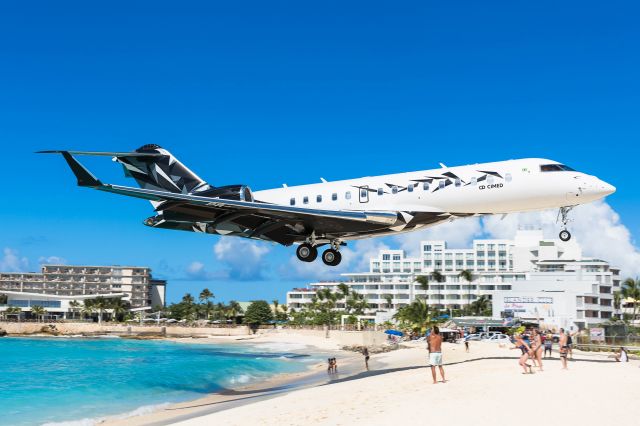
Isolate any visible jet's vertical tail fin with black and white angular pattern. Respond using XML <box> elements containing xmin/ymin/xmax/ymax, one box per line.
<box><xmin>115</xmin><ymin>144</ymin><xmax>210</xmax><ymax>194</ymax></box>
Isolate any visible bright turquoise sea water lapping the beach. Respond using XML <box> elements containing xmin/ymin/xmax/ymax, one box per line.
<box><xmin>0</xmin><ymin>338</ymin><xmax>319</xmax><ymax>426</ymax></box>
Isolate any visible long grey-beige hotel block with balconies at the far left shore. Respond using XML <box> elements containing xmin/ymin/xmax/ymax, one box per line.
<box><xmin>0</xmin><ymin>265</ymin><xmax>166</xmax><ymax>318</ymax></box>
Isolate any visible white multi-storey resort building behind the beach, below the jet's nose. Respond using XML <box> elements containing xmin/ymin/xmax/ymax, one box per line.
<box><xmin>287</xmin><ymin>229</ymin><xmax>620</xmax><ymax>328</ymax></box>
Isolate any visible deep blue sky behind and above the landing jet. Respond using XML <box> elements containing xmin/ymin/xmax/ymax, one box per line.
<box><xmin>0</xmin><ymin>1</ymin><xmax>640</xmax><ymax>300</ymax></box>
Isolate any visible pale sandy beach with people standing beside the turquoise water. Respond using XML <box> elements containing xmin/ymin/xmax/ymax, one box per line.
<box><xmin>105</xmin><ymin>332</ymin><xmax>640</xmax><ymax>426</ymax></box>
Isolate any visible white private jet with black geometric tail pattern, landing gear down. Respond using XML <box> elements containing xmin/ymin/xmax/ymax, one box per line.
<box><xmin>41</xmin><ymin>145</ymin><xmax>615</xmax><ymax>266</ymax></box>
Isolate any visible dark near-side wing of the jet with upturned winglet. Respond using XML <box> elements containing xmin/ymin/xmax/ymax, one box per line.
<box><xmin>47</xmin><ymin>151</ymin><xmax>406</xmax><ymax>245</ymax></box>
